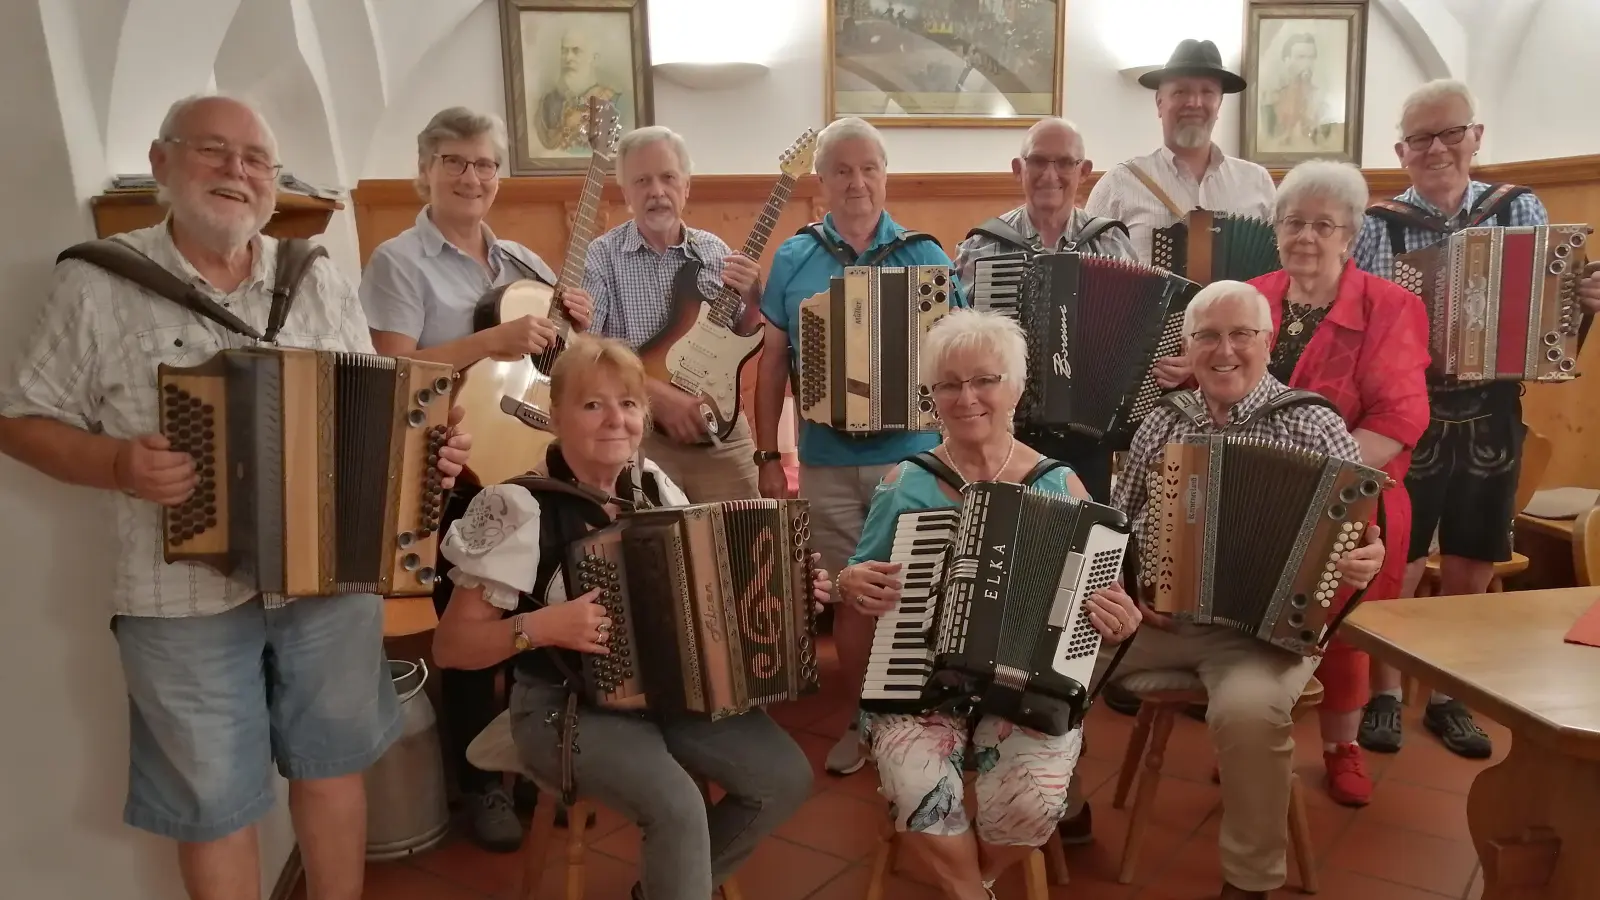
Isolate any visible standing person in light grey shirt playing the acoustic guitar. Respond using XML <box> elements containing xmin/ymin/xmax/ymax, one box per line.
<box><xmin>360</xmin><ymin>106</ymin><xmax>592</xmax><ymax>854</ymax></box>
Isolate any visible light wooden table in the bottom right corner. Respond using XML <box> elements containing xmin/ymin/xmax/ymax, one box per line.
<box><xmin>1339</xmin><ymin>588</ymin><xmax>1600</xmax><ymax>900</ymax></box>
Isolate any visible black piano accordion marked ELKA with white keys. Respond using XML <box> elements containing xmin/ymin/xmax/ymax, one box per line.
<box><xmin>861</xmin><ymin>482</ymin><xmax>1128</xmax><ymax>735</ymax></box>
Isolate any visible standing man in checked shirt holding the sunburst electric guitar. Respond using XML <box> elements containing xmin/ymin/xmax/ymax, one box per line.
<box><xmin>584</xmin><ymin>125</ymin><xmax>762</xmax><ymax>503</ymax></box>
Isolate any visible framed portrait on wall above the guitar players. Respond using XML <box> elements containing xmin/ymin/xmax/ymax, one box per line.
<box><xmin>499</xmin><ymin>0</ymin><xmax>654</xmax><ymax>175</ymax></box>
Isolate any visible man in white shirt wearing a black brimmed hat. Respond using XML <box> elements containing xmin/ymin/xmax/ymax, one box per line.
<box><xmin>1083</xmin><ymin>38</ymin><xmax>1277</xmax><ymax>267</ymax></box>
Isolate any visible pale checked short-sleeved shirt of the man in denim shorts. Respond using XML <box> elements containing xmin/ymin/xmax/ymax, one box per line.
<box><xmin>0</xmin><ymin>221</ymin><xmax>373</xmax><ymax>618</ymax></box>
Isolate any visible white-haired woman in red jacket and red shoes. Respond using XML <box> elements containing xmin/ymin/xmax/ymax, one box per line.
<box><xmin>1250</xmin><ymin>160</ymin><xmax>1429</xmax><ymax>806</ymax></box>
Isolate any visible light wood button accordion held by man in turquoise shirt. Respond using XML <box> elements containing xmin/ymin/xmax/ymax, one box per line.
<box><xmin>797</xmin><ymin>266</ymin><xmax>952</xmax><ymax>434</ymax></box>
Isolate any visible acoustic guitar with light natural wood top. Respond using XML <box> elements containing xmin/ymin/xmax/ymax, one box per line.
<box><xmin>456</xmin><ymin>98</ymin><xmax>621</xmax><ymax>487</ymax></box>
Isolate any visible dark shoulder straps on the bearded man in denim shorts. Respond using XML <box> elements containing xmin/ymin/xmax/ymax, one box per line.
<box><xmin>56</xmin><ymin>237</ymin><xmax>328</xmax><ymax>344</ymax></box>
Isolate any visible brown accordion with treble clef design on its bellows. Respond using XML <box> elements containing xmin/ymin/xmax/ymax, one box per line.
<box><xmin>566</xmin><ymin>500</ymin><xmax>818</xmax><ymax>719</ymax></box>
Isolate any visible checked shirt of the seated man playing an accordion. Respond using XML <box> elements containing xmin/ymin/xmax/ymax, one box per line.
<box><xmin>1110</xmin><ymin>375</ymin><xmax>1362</xmax><ymax>541</ymax></box>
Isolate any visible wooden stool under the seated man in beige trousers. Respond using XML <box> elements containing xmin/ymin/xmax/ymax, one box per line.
<box><xmin>1112</xmin><ymin>669</ymin><xmax>1322</xmax><ymax>894</ymax></box>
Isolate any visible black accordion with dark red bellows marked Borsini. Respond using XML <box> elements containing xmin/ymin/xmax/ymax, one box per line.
<box><xmin>973</xmin><ymin>253</ymin><xmax>1200</xmax><ymax>440</ymax></box>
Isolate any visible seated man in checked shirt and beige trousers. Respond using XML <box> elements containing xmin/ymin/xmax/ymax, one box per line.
<box><xmin>1112</xmin><ymin>282</ymin><xmax>1384</xmax><ymax>900</ymax></box>
